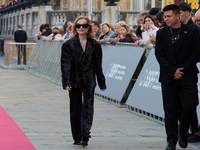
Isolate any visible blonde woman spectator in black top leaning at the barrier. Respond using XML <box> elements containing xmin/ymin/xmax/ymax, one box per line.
<box><xmin>119</xmin><ymin>25</ymin><xmax>134</xmax><ymax>43</ymax></box>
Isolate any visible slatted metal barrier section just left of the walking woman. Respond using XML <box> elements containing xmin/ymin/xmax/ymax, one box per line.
<box><xmin>25</xmin><ymin>40</ymin><xmax>63</xmax><ymax>84</ymax></box>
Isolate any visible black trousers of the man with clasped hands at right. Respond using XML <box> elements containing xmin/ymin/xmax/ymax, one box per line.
<box><xmin>161</xmin><ymin>81</ymin><xmax>198</xmax><ymax>144</ymax></box>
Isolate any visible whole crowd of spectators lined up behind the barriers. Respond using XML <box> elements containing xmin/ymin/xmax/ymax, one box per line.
<box><xmin>35</xmin><ymin>4</ymin><xmax>198</xmax><ymax>46</ymax></box>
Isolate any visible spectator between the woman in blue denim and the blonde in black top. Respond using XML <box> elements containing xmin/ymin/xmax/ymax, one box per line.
<box><xmin>105</xmin><ymin>22</ymin><xmax>124</xmax><ymax>45</ymax></box>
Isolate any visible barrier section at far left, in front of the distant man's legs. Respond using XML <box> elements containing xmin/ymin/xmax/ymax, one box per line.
<box><xmin>4</xmin><ymin>42</ymin><xmax>36</xmax><ymax>69</ymax></box>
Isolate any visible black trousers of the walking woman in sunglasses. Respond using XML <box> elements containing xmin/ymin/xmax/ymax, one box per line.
<box><xmin>69</xmin><ymin>88</ymin><xmax>94</xmax><ymax>141</ymax></box>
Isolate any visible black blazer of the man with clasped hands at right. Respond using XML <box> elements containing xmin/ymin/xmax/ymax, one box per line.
<box><xmin>155</xmin><ymin>24</ymin><xmax>200</xmax><ymax>83</ymax></box>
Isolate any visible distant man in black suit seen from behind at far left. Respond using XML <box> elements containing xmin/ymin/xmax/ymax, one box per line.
<box><xmin>14</xmin><ymin>25</ymin><xmax>27</xmax><ymax>65</ymax></box>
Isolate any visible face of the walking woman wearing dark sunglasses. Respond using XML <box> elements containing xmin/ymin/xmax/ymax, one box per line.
<box><xmin>76</xmin><ymin>19</ymin><xmax>90</xmax><ymax>35</ymax></box>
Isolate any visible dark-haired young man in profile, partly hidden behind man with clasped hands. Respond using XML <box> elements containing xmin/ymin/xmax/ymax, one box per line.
<box><xmin>178</xmin><ymin>2</ymin><xmax>200</xmax><ymax>143</ymax></box>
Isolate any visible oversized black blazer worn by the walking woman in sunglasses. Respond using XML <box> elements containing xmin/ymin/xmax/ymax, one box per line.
<box><xmin>61</xmin><ymin>36</ymin><xmax>106</xmax><ymax>89</ymax></box>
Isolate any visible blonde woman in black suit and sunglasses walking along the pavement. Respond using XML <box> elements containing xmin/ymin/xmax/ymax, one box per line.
<box><xmin>61</xmin><ymin>16</ymin><xmax>106</xmax><ymax>146</ymax></box>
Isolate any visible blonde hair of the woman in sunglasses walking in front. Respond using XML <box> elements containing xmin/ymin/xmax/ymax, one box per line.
<box><xmin>71</xmin><ymin>16</ymin><xmax>94</xmax><ymax>39</ymax></box>
